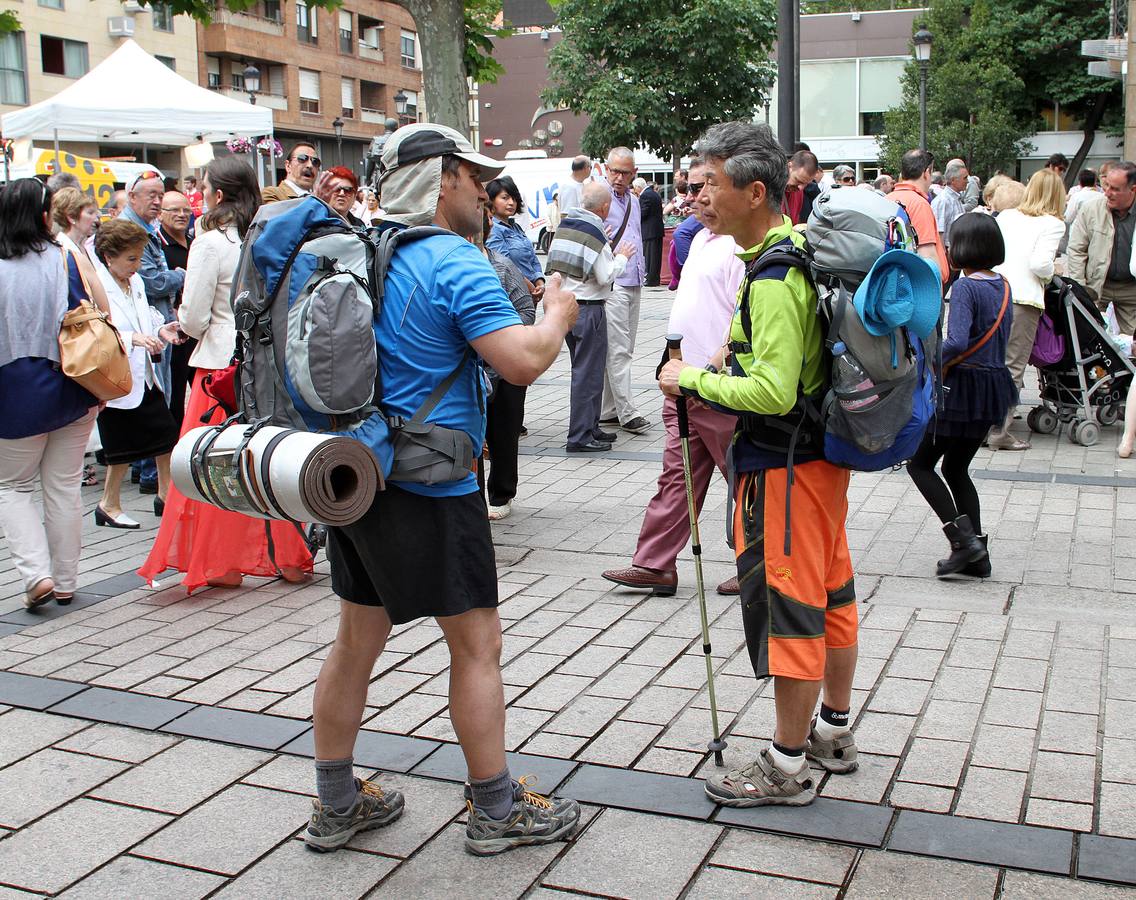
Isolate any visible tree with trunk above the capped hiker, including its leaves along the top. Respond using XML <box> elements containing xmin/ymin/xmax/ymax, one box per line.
<box><xmin>0</xmin><ymin>0</ymin><xmax>511</xmax><ymax>134</ymax></box>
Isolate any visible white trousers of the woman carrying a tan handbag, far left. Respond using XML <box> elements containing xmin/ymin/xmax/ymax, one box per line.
<box><xmin>0</xmin><ymin>409</ymin><xmax>98</xmax><ymax>593</ymax></box>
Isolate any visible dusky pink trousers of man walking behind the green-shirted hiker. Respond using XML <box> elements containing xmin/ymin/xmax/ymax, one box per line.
<box><xmin>632</xmin><ymin>397</ymin><xmax>737</xmax><ymax>572</ymax></box>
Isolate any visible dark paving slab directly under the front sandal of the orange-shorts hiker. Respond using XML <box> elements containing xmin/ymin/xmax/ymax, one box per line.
<box><xmin>715</xmin><ymin>797</ymin><xmax>894</xmax><ymax>847</ymax></box>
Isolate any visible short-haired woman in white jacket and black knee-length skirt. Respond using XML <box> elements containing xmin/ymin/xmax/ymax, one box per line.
<box><xmin>94</xmin><ymin>218</ymin><xmax>184</xmax><ymax>528</ymax></box>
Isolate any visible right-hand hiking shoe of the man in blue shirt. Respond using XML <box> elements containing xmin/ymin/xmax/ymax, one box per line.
<box><xmin>466</xmin><ymin>778</ymin><xmax>579</xmax><ymax>856</ymax></box>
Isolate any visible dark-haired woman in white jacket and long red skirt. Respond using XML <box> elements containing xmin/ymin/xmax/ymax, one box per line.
<box><xmin>139</xmin><ymin>157</ymin><xmax>311</xmax><ymax>593</ymax></box>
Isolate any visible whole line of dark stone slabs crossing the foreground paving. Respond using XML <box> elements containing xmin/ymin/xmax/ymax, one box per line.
<box><xmin>0</xmin><ymin>672</ymin><xmax>1136</xmax><ymax>884</ymax></box>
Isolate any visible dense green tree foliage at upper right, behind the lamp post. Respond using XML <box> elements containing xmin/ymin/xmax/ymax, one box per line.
<box><xmin>880</xmin><ymin>0</ymin><xmax>1120</xmax><ymax>176</ymax></box>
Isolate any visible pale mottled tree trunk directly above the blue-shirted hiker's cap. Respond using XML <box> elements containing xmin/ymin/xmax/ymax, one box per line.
<box><xmin>396</xmin><ymin>0</ymin><xmax>469</xmax><ymax>138</ymax></box>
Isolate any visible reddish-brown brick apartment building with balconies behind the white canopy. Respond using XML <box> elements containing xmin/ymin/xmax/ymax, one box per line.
<box><xmin>198</xmin><ymin>0</ymin><xmax>424</xmax><ymax>177</ymax></box>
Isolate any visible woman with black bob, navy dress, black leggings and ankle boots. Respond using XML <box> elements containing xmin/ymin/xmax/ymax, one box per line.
<box><xmin>908</xmin><ymin>213</ymin><xmax>1018</xmax><ymax>578</ymax></box>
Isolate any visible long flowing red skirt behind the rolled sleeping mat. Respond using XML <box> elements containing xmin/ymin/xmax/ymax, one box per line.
<box><xmin>139</xmin><ymin>369</ymin><xmax>312</xmax><ymax>593</ymax></box>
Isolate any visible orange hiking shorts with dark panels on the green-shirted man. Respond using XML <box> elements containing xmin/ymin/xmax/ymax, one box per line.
<box><xmin>733</xmin><ymin>460</ymin><xmax>858</xmax><ymax>681</ymax></box>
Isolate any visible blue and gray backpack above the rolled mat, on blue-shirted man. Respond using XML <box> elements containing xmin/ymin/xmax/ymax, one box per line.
<box><xmin>232</xmin><ymin>197</ymin><xmax>481</xmax><ymax>484</ymax></box>
